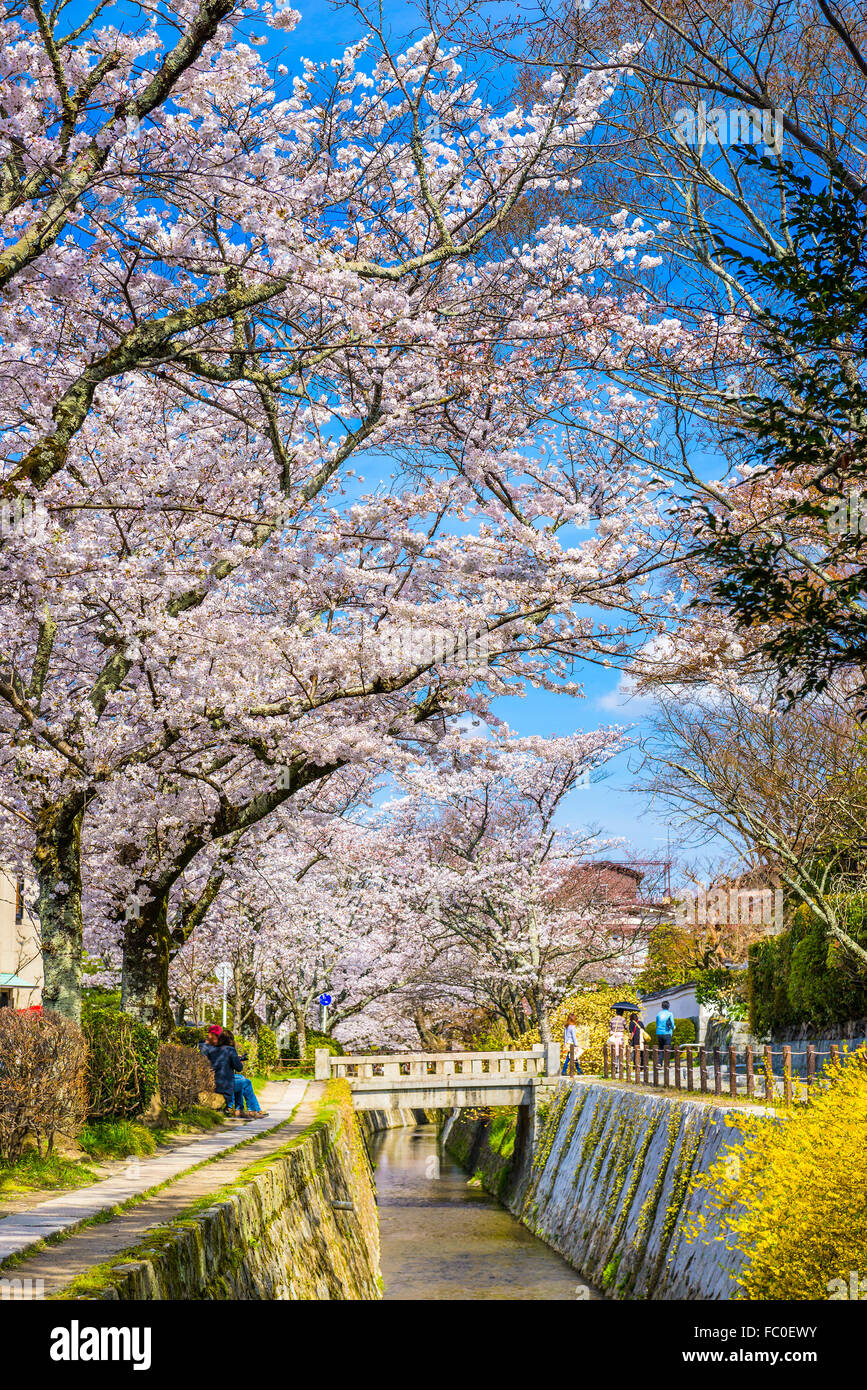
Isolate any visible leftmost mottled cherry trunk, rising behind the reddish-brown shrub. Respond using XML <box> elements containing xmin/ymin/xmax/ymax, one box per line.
<box><xmin>33</xmin><ymin>791</ymin><xmax>86</xmax><ymax>1022</ymax></box>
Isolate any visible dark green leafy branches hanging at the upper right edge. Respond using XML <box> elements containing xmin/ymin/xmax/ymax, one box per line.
<box><xmin>697</xmin><ymin>160</ymin><xmax>867</xmax><ymax>703</ymax></box>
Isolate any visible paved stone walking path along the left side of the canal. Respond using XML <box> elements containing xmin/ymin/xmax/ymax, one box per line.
<box><xmin>0</xmin><ymin>1079</ymin><xmax>308</xmax><ymax>1273</ymax></box>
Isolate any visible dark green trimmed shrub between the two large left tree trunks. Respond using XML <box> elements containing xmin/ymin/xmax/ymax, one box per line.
<box><xmin>82</xmin><ymin>1009</ymin><xmax>160</xmax><ymax>1120</ymax></box>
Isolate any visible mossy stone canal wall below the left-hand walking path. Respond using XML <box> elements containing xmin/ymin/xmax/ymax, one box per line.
<box><xmin>72</xmin><ymin>1081</ymin><xmax>382</xmax><ymax>1301</ymax></box>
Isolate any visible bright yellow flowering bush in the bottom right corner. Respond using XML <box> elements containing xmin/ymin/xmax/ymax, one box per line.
<box><xmin>685</xmin><ymin>1047</ymin><xmax>867</xmax><ymax>1300</ymax></box>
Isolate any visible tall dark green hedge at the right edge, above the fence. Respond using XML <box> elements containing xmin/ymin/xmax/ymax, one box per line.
<box><xmin>748</xmin><ymin>898</ymin><xmax>867</xmax><ymax>1037</ymax></box>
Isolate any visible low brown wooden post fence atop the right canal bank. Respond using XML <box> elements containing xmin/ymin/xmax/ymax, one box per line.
<box><xmin>603</xmin><ymin>1043</ymin><xmax>839</xmax><ymax>1105</ymax></box>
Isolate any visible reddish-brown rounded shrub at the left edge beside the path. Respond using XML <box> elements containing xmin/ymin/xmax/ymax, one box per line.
<box><xmin>0</xmin><ymin>1009</ymin><xmax>88</xmax><ymax>1163</ymax></box>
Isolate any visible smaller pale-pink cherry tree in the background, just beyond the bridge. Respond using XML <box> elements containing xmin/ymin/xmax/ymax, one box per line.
<box><xmin>372</xmin><ymin>728</ymin><xmax>652</xmax><ymax>1041</ymax></box>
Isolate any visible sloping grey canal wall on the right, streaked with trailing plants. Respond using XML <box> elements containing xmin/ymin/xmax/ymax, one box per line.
<box><xmin>447</xmin><ymin>1083</ymin><xmax>742</xmax><ymax>1300</ymax></box>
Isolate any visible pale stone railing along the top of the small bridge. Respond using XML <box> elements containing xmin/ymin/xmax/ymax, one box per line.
<box><xmin>314</xmin><ymin>1043</ymin><xmax>560</xmax><ymax>1083</ymax></box>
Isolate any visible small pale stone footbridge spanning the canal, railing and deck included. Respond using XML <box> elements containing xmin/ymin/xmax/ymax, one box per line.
<box><xmin>314</xmin><ymin>1043</ymin><xmax>560</xmax><ymax>1111</ymax></box>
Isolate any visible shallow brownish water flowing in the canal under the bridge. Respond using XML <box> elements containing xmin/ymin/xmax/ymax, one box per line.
<box><xmin>370</xmin><ymin>1125</ymin><xmax>600</xmax><ymax>1301</ymax></box>
